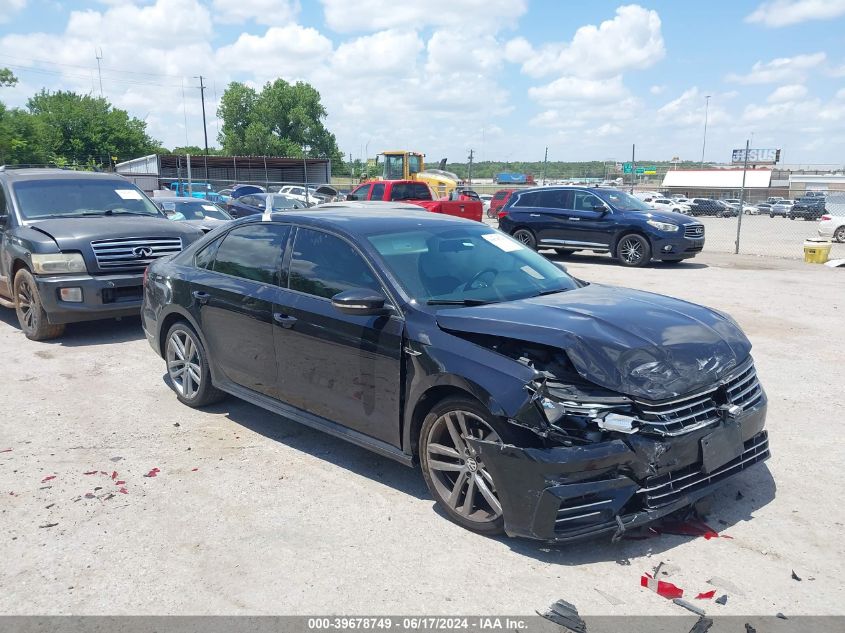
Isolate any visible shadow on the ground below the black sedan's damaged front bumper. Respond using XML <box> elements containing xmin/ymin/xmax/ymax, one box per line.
<box><xmin>500</xmin><ymin>464</ymin><xmax>777</xmax><ymax>571</ymax></box>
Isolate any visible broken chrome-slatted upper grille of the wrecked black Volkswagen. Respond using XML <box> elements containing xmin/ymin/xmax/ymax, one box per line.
<box><xmin>637</xmin><ymin>361</ymin><xmax>763</xmax><ymax>436</ymax></box>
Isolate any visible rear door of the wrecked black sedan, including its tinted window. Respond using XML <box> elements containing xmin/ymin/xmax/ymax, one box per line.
<box><xmin>191</xmin><ymin>222</ymin><xmax>290</xmax><ymax>397</ymax></box>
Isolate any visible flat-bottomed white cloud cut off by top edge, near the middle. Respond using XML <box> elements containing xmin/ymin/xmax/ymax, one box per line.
<box><xmin>322</xmin><ymin>0</ymin><xmax>527</xmax><ymax>33</ymax></box>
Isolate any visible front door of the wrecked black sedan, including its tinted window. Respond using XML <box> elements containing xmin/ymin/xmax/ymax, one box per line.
<box><xmin>274</xmin><ymin>227</ymin><xmax>404</xmax><ymax>446</ymax></box>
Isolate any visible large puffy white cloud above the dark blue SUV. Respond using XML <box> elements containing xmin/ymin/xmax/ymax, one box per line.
<box><xmin>505</xmin><ymin>4</ymin><xmax>666</xmax><ymax>77</ymax></box>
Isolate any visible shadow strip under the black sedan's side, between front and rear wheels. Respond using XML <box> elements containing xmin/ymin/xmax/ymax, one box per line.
<box><xmin>202</xmin><ymin>396</ymin><xmax>431</xmax><ymax>499</ymax></box>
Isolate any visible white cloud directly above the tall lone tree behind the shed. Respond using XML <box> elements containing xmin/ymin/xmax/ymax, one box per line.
<box><xmin>214</xmin><ymin>24</ymin><xmax>332</xmax><ymax>83</ymax></box>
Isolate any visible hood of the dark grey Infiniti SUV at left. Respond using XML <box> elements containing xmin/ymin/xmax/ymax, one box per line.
<box><xmin>30</xmin><ymin>215</ymin><xmax>198</xmax><ymax>250</ymax></box>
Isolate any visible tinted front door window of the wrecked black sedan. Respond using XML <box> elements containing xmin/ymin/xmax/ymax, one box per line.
<box><xmin>289</xmin><ymin>228</ymin><xmax>381</xmax><ymax>298</ymax></box>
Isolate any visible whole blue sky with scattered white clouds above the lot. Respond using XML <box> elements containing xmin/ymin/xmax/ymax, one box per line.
<box><xmin>0</xmin><ymin>0</ymin><xmax>845</xmax><ymax>165</ymax></box>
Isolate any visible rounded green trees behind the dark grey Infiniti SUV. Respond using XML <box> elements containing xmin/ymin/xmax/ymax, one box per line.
<box><xmin>27</xmin><ymin>90</ymin><xmax>161</xmax><ymax>165</ymax></box>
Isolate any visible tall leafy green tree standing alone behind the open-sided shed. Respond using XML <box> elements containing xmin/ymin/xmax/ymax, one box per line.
<box><xmin>217</xmin><ymin>79</ymin><xmax>343</xmax><ymax>167</ymax></box>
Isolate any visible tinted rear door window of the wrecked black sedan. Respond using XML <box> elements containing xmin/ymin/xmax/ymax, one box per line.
<box><xmin>214</xmin><ymin>222</ymin><xmax>290</xmax><ymax>285</ymax></box>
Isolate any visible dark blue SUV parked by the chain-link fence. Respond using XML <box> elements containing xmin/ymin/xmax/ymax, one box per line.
<box><xmin>499</xmin><ymin>187</ymin><xmax>704</xmax><ymax>266</ymax></box>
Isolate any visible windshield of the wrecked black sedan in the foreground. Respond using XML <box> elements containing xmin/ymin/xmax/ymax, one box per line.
<box><xmin>367</xmin><ymin>226</ymin><xmax>580</xmax><ymax>305</ymax></box>
